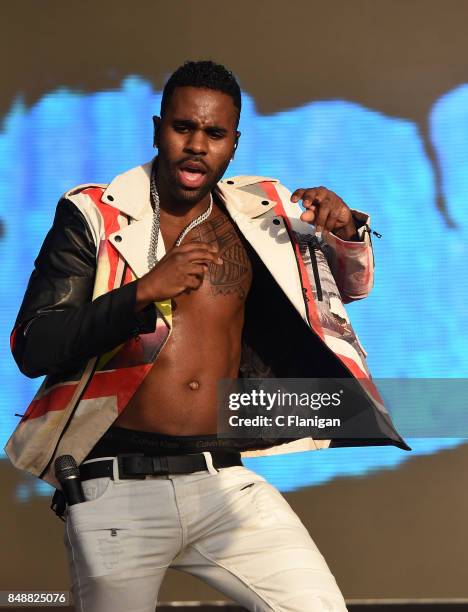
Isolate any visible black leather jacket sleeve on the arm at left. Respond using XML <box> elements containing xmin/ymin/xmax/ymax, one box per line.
<box><xmin>10</xmin><ymin>198</ymin><xmax>157</xmax><ymax>378</ymax></box>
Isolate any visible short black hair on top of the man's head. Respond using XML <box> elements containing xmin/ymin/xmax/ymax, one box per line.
<box><xmin>161</xmin><ymin>60</ymin><xmax>241</xmax><ymax>123</ymax></box>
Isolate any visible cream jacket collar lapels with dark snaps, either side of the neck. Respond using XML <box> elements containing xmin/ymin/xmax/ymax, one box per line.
<box><xmin>101</xmin><ymin>158</ymin><xmax>278</xmax><ymax>221</ymax></box>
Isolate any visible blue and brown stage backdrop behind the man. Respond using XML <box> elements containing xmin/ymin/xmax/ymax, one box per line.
<box><xmin>0</xmin><ymin>0</ymin><xmax>468</xmax><ymax>599</ymax></box>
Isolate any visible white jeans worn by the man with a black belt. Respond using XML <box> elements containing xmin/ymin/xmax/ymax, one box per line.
<box><xmin>64</xmin><ymin>453</ymin><xmax>346</xmax><ymax>612</ymax></box>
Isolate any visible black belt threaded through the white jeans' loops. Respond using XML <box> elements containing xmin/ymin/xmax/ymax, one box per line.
<box><xmin>80</xmin><ymin>450</ymin><xmax>243</xmax><ymax>480</ymax></box>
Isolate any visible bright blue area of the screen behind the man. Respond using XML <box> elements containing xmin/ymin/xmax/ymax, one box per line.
<box><xmin>0</xmin><ymin>77</ymin><xmax>468</xmax><ymax>499</ymax></box>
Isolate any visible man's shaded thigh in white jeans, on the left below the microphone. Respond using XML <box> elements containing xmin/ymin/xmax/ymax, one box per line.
<box><xmin>64</xmin><ymin>478</ymin><xmax>181</xmax><ymax>612</ymax></box>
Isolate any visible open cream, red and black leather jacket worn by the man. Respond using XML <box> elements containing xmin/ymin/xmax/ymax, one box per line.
<box><xmin>5</xmin><ymin>161</ymin><xmax>409</xmax><ymax>487</ymax></box>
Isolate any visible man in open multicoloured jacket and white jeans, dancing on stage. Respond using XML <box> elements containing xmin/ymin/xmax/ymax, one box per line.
<box><xmin>6</xmin><ymin>62</ymin><xmax>405</xmax><ymax>612</ymax></box>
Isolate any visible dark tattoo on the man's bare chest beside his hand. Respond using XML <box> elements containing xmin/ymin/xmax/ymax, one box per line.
<box><xmin>190</xmin><ymin>215</ymin><xmax>252</xmax><ymax>299</ymax></box>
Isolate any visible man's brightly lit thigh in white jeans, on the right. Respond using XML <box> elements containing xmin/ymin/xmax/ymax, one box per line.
<box><xmin>172</xmin><ymin>469</ymin><xmax>346</xmax><ymax>612</ymax></box>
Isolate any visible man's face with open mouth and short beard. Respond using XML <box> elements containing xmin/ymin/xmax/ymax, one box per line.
<box><xmin>155</xmin><ymin>87</ymin><xmax>240</xmax><ymax>203</ymax></box>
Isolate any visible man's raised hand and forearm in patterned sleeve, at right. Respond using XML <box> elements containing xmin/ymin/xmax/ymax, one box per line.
<box><xmin>291</xmin><ymin>187</ymin><xmax>374</xmax><ymax>304</ymax></box>
